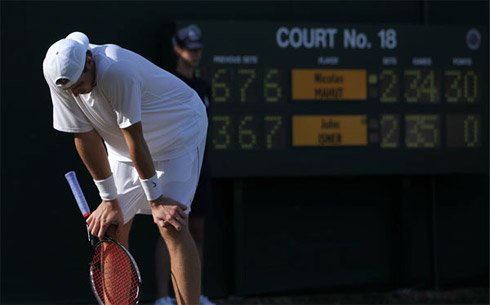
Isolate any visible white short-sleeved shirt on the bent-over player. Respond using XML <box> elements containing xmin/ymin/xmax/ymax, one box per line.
<box><xmin>47</xmin><ymin>44</ymin><xmax>207</xmax><ymax>161</ymax></box>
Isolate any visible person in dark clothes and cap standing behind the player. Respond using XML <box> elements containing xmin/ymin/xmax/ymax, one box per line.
<box><xmin>155</xmin><ymin>25</ymin><xmax>214</xmax><ymax>305</ymax></box>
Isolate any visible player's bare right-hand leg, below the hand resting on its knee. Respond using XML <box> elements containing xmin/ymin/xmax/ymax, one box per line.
<box><xmin>159</xmin><ymin>217</ymin><xmax>201</xmax><ymax>305</ymax></box>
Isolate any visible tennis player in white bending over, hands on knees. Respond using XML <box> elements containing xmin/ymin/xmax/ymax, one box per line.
<box><xmin>43</xmin><ymin>32</ymin><xmax>208</xmax><ymax>304</ymax></box>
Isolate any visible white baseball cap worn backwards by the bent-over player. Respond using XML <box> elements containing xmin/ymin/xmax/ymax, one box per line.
<box><xmin>43</xmin><ymin>32</ymin><xmax>89</xmax><ymax>89</ymax></box>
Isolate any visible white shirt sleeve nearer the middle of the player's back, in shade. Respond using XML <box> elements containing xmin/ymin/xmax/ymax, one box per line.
<box><xmin>97</xmin><ymin>61</ymin><xmax>141</xmax><ymax>128</ymax></box>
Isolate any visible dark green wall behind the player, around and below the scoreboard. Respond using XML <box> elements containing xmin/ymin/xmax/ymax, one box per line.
<box><xmin>0</xmin><ymin>1</ymin><xmax>489</xmax><ymax>304</ymax></box>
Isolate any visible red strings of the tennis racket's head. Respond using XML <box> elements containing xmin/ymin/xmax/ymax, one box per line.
<box><xmin>91</xmin><ymin>242</ymin><xmax>139</xmax><ymax>305</ymax></box>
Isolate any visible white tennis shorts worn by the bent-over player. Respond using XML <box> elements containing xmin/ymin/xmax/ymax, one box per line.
<box><xmin>109</xmin><ymin>139</ymin><xmax>206</xmax><ymax>223</ymax></box>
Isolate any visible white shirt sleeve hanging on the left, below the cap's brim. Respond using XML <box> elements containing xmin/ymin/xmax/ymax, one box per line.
<box><xmin>49</xmin><ymin>85</ymin><xmax>93</xmax><ymax>133</ymax></box>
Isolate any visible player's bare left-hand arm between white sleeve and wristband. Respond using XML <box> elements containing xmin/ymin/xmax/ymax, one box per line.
<box><xmin>74</xmin><ymin>129</ymin><xmax>112</xmax><ymax>180</ymax></box>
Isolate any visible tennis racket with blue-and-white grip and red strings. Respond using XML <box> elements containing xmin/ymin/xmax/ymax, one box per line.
<box><xmin>65</xmin><ymin>171</ymin><xmax>141</xmax><ymax>305</ymax></box>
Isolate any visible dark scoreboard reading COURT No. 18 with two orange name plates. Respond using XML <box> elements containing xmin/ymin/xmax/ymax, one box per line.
<box><xmin>178</xmin><ymin>21</ymin><xmax>489</xmax><ymax>177</ymax></box>
